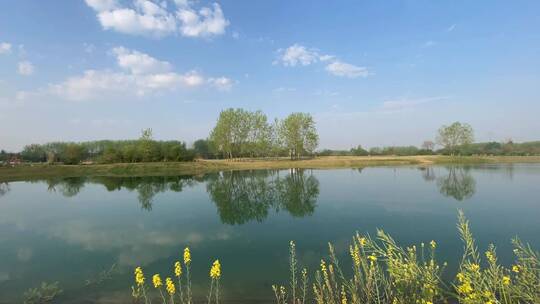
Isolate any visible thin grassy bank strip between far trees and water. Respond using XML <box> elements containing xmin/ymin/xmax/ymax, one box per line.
<box><xmin>0</xmin><ymin>155</ymin><xmax>540</xmax><ymax>181</ymax></box>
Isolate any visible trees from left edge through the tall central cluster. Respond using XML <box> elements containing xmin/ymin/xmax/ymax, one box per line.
<box><xmin>5</xmin><ymin>109</ymin><xmax>319</xmax><ymax>165</ymax></box>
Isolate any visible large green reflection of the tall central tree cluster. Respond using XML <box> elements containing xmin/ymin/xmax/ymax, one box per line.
<box><xmin>206</xmin><ymin>169</ymin><xmax>319</xmax><ymax>225</ymax></box>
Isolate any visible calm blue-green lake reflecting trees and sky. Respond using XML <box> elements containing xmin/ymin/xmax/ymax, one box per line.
<box><xmin>0</xmin><ymin>164</ymin><xmax>540</xmax><ymax>303</ymax></box>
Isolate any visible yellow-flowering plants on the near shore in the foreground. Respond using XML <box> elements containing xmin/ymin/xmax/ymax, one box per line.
<box><xmin>123</xmin><ymin>211</ymin><xmax>540</xmax><ymax>304</ymax></box>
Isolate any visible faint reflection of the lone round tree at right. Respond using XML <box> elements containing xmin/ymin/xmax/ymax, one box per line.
<box><xmin>437</xmin><ymin>167</ymin><xmax>476</xmax><ymax>201</ymax></box>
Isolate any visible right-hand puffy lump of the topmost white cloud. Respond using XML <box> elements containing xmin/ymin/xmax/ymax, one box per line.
<box><xmin>177</xmin><ymin>3</ymin><xmax>229</xmax><ymax>37</ymax></box>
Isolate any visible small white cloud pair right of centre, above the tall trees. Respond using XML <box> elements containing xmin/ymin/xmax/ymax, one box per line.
<box><xmin>273</xmin><ymin>43</ymin><xmax>370</xmax><ymax>78</ymax></box>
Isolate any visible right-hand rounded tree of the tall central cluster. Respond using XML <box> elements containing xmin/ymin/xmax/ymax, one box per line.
<box><xmin>279</xmin><ymin>113</ymin><xmax>319</xmax><ymax>159</ymax></box>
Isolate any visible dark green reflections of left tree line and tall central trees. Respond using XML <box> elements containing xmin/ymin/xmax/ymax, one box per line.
<box><xmin>27</xmin><ymin>169</ymin><xmax>319</xmax><ymax>220</ymax></box>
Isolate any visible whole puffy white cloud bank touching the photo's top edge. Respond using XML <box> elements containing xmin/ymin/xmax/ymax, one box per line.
<box><xmin>86</xmin><ymin>0</ymin><xmax>229</xmax><ymax>37</ymax></box>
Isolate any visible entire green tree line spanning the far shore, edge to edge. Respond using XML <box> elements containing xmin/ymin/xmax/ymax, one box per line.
<box><xmin>0</xmin><ymin>114</ymin><xmax>540</xmax><ymax>164</ymax></box>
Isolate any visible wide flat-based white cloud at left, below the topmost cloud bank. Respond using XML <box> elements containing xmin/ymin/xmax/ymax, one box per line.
<box><xmin>49</xmin><ymin>47</ymin><xmax>233</xmax><ymax>100</ymax></box>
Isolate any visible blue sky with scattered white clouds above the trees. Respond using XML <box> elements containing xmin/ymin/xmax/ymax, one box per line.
<box><xmin>0</xmin><ymin>0</ymin><xmax>540</xmax><ymax>150</ymax></box>
